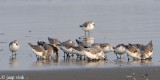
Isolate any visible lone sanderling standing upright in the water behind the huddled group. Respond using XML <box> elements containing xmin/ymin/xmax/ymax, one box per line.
<box><xmin>80</xmin><ymin>21</ymin><xmax>95</xmax><ymax>36</ymax></box>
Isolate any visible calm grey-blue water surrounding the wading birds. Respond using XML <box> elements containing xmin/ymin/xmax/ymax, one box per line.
<box><xmin>0</xmin><ymin>0</ymin><xmax>160</xmax><ymax>70</ymax></box>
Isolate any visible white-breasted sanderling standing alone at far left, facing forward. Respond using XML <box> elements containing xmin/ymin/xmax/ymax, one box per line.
<box><xmin>9</xmin><ymin>40</ymin><xmax>19</xmax><ymax>56</ymax></box>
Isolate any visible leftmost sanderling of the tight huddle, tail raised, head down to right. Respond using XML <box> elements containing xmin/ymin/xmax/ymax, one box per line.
<box><xmin>28</xmin><ymin>43</ymin><xmax>47</xmax><ymax>59</ymax></box>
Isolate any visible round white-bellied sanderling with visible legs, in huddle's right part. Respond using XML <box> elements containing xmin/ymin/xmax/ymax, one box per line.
<box><xmin>114</xmin><ymin>44</ymin><xmax>126</xmax><ymax>59</ymax></box>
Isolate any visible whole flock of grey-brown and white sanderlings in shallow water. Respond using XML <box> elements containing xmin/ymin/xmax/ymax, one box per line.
<box><xmin>9</xmin><ymin>21</ymin><xmax>153</xmax><ymax>61</ymax></box>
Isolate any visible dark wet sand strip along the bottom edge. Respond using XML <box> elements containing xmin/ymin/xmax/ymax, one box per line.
<box><xmin>0</xmin><ymin>66</ymin><xmax>160</xmax><ymax>80</ymax></box>
